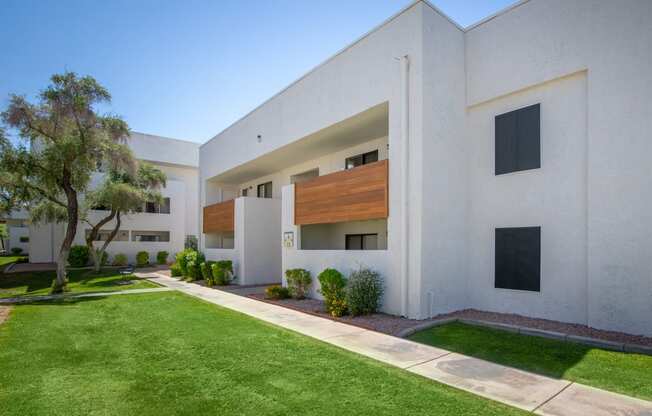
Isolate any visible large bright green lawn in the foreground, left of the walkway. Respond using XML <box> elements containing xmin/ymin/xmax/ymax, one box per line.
<box><xmin>0</xmin><ymin>292</ymin><xmax>526</xmax><ymax>416</ymax></box>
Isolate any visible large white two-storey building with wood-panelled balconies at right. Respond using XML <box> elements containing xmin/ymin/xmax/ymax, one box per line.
<box><xmin>199</xmin><ymin>0</ymin><xmax>652</xmax><ymax>335</ymax></box>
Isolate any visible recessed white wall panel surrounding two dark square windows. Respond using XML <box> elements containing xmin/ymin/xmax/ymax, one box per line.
<box><xmin>467</xmin><ymin>72</ymin><xmax>587</xmax><ymax>324</ymax></box>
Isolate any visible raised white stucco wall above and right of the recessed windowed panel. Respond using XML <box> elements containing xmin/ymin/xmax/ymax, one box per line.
<box><xmin>466</xmin><ymin>0</ymin><xmax>652</xmax><ymax>335</ymax></box>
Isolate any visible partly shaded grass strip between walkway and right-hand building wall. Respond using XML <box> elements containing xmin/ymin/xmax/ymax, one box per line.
<box><xmin>410</xmin><ymin>322</ymin><xmax>652</xmax><ymax>400</ymax></box>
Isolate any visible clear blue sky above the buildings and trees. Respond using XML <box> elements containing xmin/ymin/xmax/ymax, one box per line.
<box><xmin>0</xmin><ymin>0</ymin><xmax>513</xmax><ymax>142</ymax></box>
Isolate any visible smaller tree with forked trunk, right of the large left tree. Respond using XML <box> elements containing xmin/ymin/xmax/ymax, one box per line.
<box><xmin>85</xmin><ymin>162</ymin><xmax>166</xmax><ymax>272</ymax></box>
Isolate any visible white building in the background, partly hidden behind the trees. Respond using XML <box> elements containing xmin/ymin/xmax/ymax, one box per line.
<box><xmin>29</xmin><ymin>133</ymin><xmax>199</xmax><ymax>263</ymax></box>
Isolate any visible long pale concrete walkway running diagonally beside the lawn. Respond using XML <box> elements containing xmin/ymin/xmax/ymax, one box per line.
<box><xmin>136</xmin><ymin>273</ymin><xmax>652</xmax><ymax>416</ymax></box>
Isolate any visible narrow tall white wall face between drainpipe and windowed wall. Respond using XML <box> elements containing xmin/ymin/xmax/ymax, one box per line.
<box><xmin>418</xmin><ymin>3</ymin><xmax>469</xmax><ymax>318</ymax></box>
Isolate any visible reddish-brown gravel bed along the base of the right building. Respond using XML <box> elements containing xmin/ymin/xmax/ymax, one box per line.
<box><xmin>249</xmin><ymin>294</ymin><xmax>652</xmax><ymax>346</ymax></box>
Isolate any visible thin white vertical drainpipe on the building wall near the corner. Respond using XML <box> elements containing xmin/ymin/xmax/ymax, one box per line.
<box><xmin>400</xmin><ymin>55</ymin><xmax>410</xmax><ymax>317</ymax></box>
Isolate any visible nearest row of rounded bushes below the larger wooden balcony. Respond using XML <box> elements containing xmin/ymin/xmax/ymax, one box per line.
<box><xmin>265</xmin><ymin>268</ymin><xmax>383</xmax><ymax>317</ymax></box>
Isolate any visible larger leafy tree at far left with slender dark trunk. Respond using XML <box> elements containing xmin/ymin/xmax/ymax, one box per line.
<box><xmin>0</xmin><ymin>72</ymin><xmax>134</xmax><ymax>293</ymax></box>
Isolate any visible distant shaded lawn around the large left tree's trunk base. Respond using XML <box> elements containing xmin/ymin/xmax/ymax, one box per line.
<box><xmin>0</xmin><ymin>270</ymin><xmax>158</xmax><ymax>298</ymax></box>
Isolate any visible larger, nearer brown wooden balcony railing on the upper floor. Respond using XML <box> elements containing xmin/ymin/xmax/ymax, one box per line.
<box><xmin>294</xmin><ymin>160</ymin><xmax>389</xmax><ymax>225</ymax></box>
